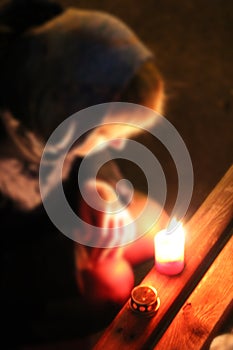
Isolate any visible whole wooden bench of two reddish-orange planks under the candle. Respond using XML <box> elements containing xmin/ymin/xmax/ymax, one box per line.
<box><xmin>94</xmin><ymin>166</ymin><xmax>233</xmax><ymax>350</ymax></box>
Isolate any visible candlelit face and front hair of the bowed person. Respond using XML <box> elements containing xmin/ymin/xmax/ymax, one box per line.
<box><xmin>75</xmin><ymin>61</ymin><xmax>164</xmax><ymax>155</ymax></box>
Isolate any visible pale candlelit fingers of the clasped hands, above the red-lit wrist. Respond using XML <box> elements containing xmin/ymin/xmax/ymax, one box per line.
<box><xmin>79</xmin><ymin>180</ymin><xmax>136</xmax><ymax>260</ymax></box>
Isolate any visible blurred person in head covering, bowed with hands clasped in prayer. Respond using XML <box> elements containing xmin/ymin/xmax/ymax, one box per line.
<box><xmin>0</xmin><ymin>0</ymin><xmax>167</xmax><ymax>346</ymax></box>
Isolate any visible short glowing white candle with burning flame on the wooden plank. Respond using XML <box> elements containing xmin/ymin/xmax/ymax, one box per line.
<box><xmin>154</xmin><ymin>218</ymin><xmax>185</xmax><ymax>275</ymax></box>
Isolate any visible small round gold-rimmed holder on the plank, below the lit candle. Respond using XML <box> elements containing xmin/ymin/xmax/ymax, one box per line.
<box><xmin>129</xmin><ymin>284</ymin><xmax>160</xmax><ymax>317</ymax></box>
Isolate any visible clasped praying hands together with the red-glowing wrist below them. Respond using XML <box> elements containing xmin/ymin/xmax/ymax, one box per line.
<box><xmin>75</xmin><ymin>180</ymin><xmax>135</xmax><ymax>305</ymax></box>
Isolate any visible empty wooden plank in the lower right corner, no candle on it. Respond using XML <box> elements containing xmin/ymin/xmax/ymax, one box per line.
<box><xmin>154</xmin><ymin>231</ymin><xmax>233</xmax><ymax>350</ymax></box>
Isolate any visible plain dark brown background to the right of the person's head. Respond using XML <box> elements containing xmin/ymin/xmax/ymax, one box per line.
<box><xmin>60</xmin><ymin>0</ymin><xmax>233</xmax><ymax>217</ymax></box>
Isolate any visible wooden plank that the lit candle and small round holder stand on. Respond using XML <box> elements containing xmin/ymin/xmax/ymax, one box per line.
<box><xmin>94</xmin><ymin>166</ymin><xmax>233</xmax><ymax>350</ymax></box>
